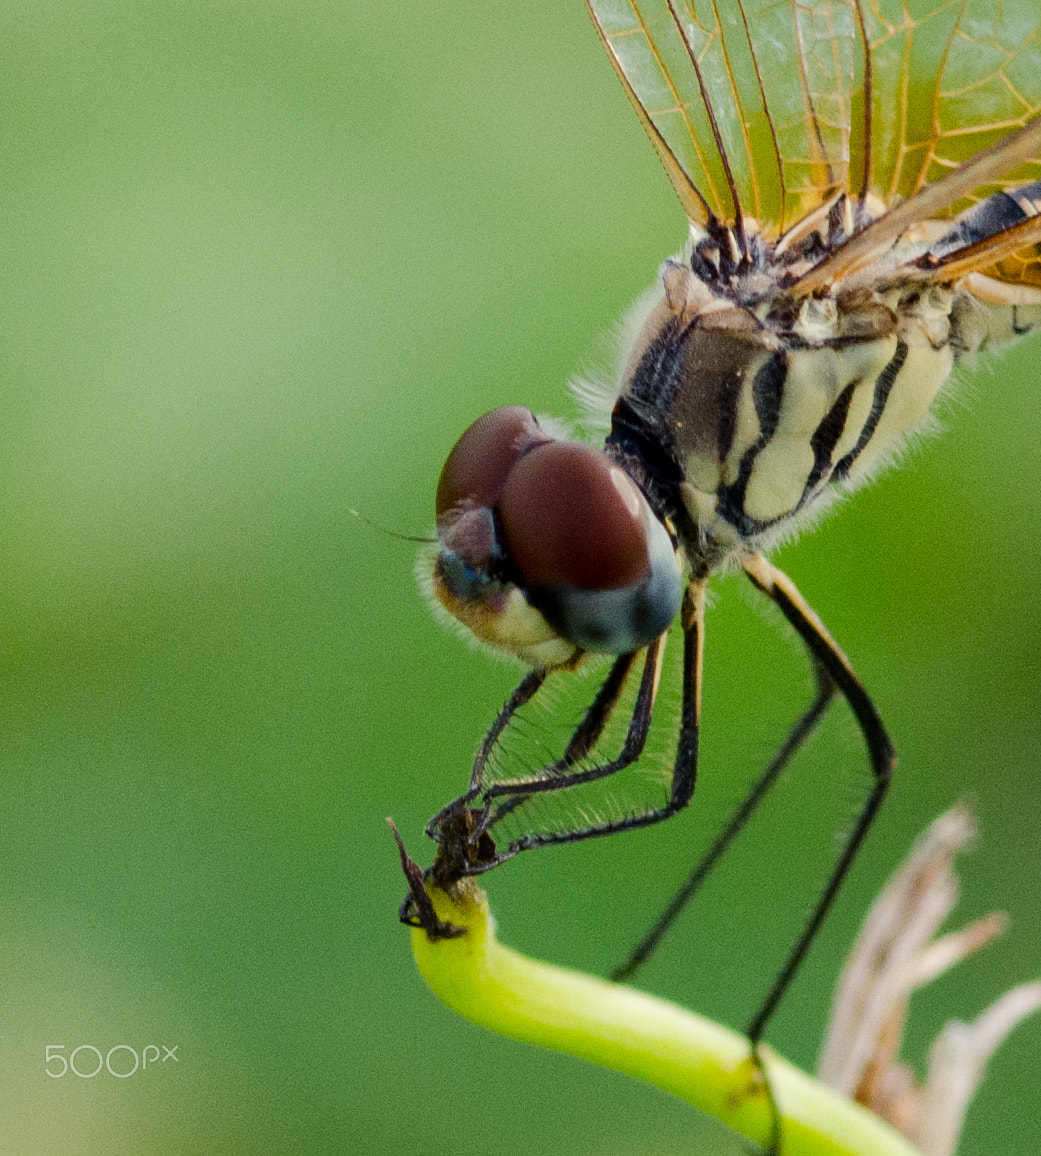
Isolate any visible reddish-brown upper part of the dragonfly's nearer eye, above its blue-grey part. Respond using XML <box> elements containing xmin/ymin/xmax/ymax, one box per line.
<box><xmin>498</xmin><ymin>442</ymin><xmax>649</xmax><ymax>591</ymax></box>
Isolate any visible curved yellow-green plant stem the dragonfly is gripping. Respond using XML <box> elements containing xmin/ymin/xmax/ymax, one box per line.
<box><xmin>412</xmin><ymin>880</ymin><xmax>919</xmax><ymax>1156</ymax></box>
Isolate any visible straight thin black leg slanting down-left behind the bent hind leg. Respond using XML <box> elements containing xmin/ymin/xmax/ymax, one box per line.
<box><xmin>610</xmin><ymin>658</ymin><xmax>835</xmax><ymax>983</ymax></box>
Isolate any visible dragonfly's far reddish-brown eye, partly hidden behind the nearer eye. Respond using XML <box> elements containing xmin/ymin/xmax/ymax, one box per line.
<box><xmin>436</xmin><ymin>406</ymin><xmax>552</xmax><ymax>519</ymax></box>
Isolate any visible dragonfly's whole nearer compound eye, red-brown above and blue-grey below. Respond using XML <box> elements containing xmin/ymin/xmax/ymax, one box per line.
<box><xmin>498</xmin><ymin>442</ymin><xmax>683</xmax><ymax>654</ymax></box>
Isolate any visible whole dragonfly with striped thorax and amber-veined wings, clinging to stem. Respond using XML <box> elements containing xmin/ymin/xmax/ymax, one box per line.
<box><xmin>404</xmin><ymin>0</ymin><xmax>1041</xmax><ymax>1137</ymax></box>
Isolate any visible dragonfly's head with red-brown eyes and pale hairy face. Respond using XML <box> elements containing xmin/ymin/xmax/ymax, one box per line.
<box><xmin>433</xmin><ymin>406</ymin><xmax>683</xmax><ymax>667</ymax></box>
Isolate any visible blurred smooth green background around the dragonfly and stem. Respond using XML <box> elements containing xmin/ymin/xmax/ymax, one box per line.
<box><xmin>0</xmin><ymin>0</ymin><xmax>1041</xmax><ymax>1156</ymax></box>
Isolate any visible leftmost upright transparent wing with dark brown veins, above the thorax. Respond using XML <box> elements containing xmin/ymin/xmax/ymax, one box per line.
<box><xmin>587</xmin><ymin>0</ymin><xmax>864</xmax><ymax>232</ymax></box>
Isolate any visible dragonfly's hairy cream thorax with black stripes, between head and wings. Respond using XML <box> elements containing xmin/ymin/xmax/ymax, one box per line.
<box><xmin>608</xmin><ymin>260</ymin><xmax>961</xmax><ymax>569</ymax></box>
